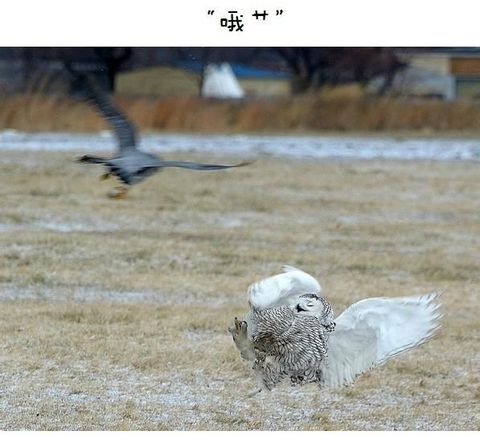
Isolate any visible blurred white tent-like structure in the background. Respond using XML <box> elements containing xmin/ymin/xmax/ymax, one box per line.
<box><xmin>202</xmin><ymin>63</ymin><xmax>245</xmax><ymax>98</ymax></box>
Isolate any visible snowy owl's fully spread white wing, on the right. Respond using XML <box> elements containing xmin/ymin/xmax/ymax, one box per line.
<box><xmin>325</xmin><ymin>294</ymin><xmax>441</xmax><ymax>387</ymax></box>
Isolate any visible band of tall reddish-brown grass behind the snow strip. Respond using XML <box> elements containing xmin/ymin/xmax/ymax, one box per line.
<box><xmin>0</xmin><ymin>91</ymin><xmax>480</xmax><ymax>134</ymax></box>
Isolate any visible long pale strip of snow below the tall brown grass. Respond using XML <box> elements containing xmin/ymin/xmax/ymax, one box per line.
<box><xmin>0</xmin><ymin>130</ymin><xmax>480</xmax><ymax>160</ymax></box>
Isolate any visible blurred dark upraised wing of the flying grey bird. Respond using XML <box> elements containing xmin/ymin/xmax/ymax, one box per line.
<box><xmin>80</xmin><ymin>74</ymin><xmax>136</xmax><ymax>150</ymax></box>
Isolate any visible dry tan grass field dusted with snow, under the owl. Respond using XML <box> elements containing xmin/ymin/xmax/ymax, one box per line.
<box><xmin>0</xmin><ymin>151</ymin><xmax>480</xmax><ymax>430</ymax></box>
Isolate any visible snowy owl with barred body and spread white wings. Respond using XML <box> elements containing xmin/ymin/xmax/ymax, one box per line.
<box><xmin>229</xmin><ymin>266</ymin><xmax>441</xmax><ymax>394</ymax></box>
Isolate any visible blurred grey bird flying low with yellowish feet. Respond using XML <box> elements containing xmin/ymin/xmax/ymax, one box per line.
<box><xmin>70</xmin><ymin>70</ymin><xmax>251</xmax><ymax>199</ymax></box>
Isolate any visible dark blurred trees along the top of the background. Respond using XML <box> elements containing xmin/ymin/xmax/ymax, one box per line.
<box><xmin>0</xmin><ymin>47</ymin><xmax>405</xmax><ymax>93</ymax></box>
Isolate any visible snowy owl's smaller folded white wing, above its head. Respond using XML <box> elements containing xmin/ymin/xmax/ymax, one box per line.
<box><xmin>247</xmin><ymin>266</ymin><xmax>322</xmax><ymax>310</ymax></box>
